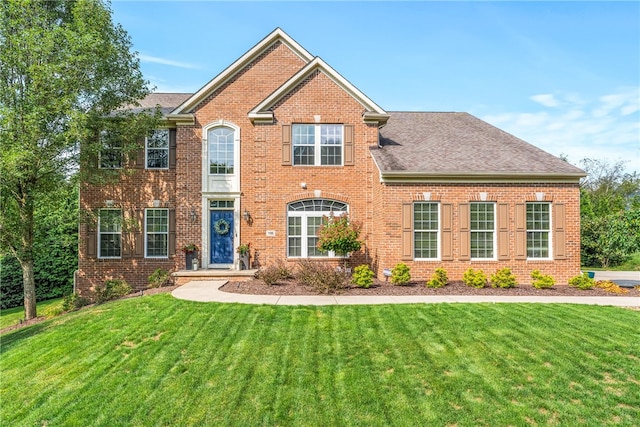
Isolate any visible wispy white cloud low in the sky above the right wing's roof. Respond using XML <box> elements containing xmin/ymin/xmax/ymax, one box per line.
<box><xmin>482</xmin><ymin>88</ymin><xmax>640</xmax><ymax>171</ymax></box>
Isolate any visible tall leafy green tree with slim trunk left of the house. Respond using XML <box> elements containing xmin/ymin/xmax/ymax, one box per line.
<box><xmin>0</xmin><ymin>0</ymin><xmax>157</xmax><ymax>319</ymax></box>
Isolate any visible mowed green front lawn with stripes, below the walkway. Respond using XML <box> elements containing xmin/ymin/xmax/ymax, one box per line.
<box><xmin>0</xmin><ymin>295</ymin><xmax>640</xmax><ymax>427</ymax></box>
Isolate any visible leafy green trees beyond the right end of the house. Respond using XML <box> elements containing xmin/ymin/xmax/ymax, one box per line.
<box><xmin>580</xmin><ymin>159</ymin><xmax>640</xmax><ymax>268</ymax></box>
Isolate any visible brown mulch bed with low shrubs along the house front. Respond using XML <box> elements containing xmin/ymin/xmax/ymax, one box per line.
<box><xmin>220</xmin><ymin>279</ymin><xmax>640</xmax><ymax>298</ymax></box>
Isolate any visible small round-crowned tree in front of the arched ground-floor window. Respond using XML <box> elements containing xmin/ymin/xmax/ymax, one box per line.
<box><xmin>317</xmin><ymin>213</ymin><xmax>362</xmax><ymax>267</ymax></box>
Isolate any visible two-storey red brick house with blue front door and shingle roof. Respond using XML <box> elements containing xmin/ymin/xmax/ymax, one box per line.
<box><xmin>77</xmin><ymin>29</ymin><xmax>584</xmax><ymax>292</ymax></box>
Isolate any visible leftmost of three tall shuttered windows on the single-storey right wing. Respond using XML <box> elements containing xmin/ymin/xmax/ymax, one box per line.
<box><xmin>413</xmin><ymin>203</ymin><xmax>440</xmax><ymax>259</ymax></box>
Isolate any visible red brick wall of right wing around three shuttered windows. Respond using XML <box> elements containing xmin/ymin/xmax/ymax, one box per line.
<box><xmin>372</xmin><ymin>179</ymin><xmax>580</xmax><ymax>284</ymax></box>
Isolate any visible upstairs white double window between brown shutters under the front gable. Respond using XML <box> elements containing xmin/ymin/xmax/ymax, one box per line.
<box><xmin>292</xmin><ymin>124</ymin><xmax>343</xmax><ymax>166</ymax></box>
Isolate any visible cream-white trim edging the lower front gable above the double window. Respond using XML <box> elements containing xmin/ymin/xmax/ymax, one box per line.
<box><xmin>248</xmin><ymin>57</ymin><xmax>389</xmax><ymax>123</ymax></box>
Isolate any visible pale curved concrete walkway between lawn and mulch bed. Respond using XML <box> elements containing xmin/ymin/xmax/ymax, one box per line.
<box><xmin>171</xmin><ymin>280</ymin><xmax>640</xmax><ymax>307</ymax></box>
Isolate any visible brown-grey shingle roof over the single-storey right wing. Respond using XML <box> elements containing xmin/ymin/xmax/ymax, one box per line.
<box><xmin>371</xmin><ymin>112</ymin><xmax>585</xmax><ymax>182</ymax></box>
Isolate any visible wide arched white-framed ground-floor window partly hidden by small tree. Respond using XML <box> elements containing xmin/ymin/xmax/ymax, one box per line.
<box><xmin>287</xmin><ymin>199</ymin><xmax>348</xmax><ymax>258</ymax></box>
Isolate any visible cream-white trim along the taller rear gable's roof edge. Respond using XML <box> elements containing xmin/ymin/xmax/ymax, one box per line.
<box><xmin>168</xmin><ymin>28</ymin><xmax>313</xmax><ymax>117</ymax></box>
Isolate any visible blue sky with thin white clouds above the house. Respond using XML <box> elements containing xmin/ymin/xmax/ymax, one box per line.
<box><xmin>112</xmin><ymin>0</ymin><xmax>640</xmax><ymax>171</ymax></box>
